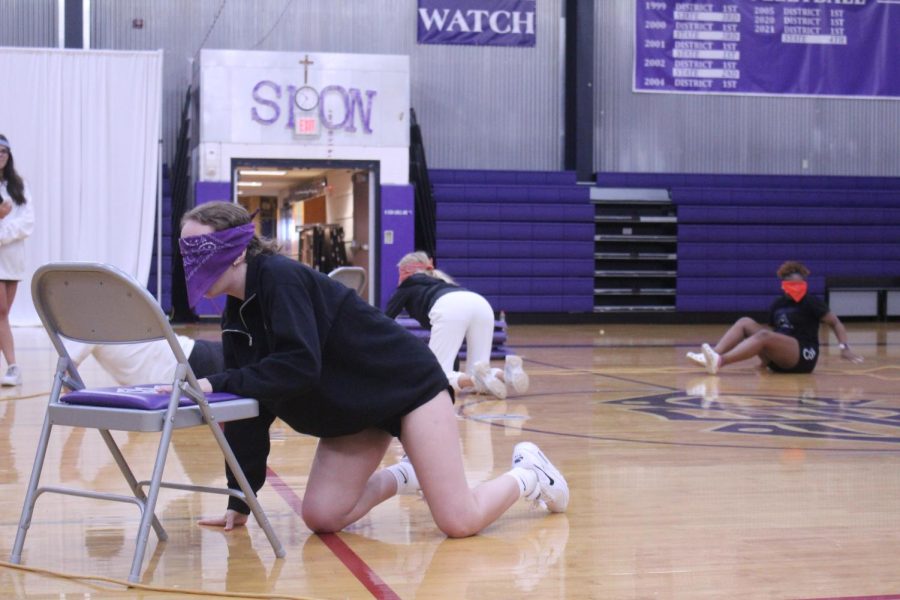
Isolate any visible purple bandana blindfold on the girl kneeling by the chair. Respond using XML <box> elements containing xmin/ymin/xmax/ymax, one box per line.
<box><xmin>178</xmin><ymin>223</ymin><xmax>255</xmax><ymax>307</ymax></box>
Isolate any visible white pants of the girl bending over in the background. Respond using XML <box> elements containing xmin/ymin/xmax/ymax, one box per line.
<box><xmin>428</xmin><ymin>291</ymin><xmax>494</xmax><ymax>390</ymax></box>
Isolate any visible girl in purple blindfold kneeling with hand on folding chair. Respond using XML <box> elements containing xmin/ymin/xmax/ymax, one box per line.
<box><xmin>180</xmin><ymin>202</ymin><xmax>569</xmax><ymax>537</ymax></box>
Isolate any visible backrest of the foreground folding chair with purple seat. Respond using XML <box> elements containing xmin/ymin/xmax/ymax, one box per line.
<box><xmin>31</xmin><ymin>262</ymin><xmax>195</xmax><ymax>383</ymax></box>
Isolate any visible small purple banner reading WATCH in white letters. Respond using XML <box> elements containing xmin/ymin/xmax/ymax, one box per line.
<box><xmin>416</xmin><ymin>0</ymin><xmax>536</xmax><ymax>47</ymax></box>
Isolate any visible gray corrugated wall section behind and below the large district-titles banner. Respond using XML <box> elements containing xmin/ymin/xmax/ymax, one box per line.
<box><xmin>594</xmin><ymin>0</ymin><xmax>900</xmax><ymax>176</ymax></box>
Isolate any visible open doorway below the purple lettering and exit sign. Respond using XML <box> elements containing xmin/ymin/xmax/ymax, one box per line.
<box><xmin>231</xmin><ymin>158</ymin><xmax>381</xmax><ymax>304</ymax></box>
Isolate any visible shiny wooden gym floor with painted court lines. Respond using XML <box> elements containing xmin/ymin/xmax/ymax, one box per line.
<box><xmin>0</xmin><ymin>322</ymin><xmax>900</xmax><ymax>600</ymax></box>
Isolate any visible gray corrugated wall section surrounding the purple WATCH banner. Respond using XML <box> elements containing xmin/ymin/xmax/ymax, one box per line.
<box><xmin>92</xmin><ymin>0</ymin><xmax>564</xmax><ymax>170</ymax></box>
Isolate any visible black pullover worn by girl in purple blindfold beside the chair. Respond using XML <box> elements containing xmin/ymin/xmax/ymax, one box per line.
<box><xmin>208</xmin><ymin>255</ymin><xmax>448</xmax><ymax>513</ymax></box>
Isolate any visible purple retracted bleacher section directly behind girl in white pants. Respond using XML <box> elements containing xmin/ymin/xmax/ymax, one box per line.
<box><xmin>429</xmin><ymin>170</ymin><xmax>594</xmax><ymax>313</ymax></box>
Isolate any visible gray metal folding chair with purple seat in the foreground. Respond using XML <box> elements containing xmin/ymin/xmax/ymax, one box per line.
<box><xmin>10</xmin><ymin>263</ymin><xmax>285</xmax><ymax>582</ymax></box>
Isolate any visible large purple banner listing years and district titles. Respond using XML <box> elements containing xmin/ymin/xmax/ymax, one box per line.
<box><xmin>634</xmin><ymin>0</ymin><xmax>900</xmax><ymax>97</ymax></box>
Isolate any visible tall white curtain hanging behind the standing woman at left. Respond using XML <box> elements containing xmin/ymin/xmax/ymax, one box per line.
<box><xmin>0</xmin><ymin>48</ymin><xmax>163</xmax><ymax>325</ymax></box>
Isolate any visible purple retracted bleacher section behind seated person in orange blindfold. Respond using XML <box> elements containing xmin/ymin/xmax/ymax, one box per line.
<box><xmin>598</xmin><ymin>173</ymin><xmax>900</xmax><ymax>313</ymax></box>
